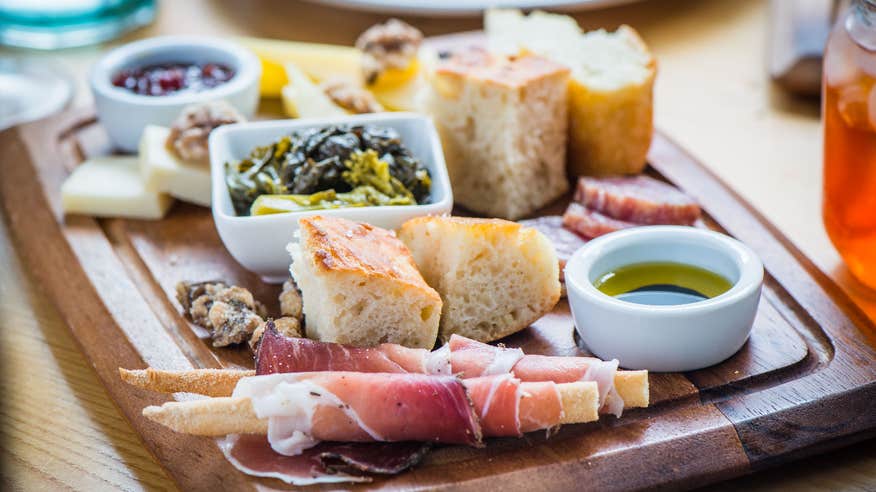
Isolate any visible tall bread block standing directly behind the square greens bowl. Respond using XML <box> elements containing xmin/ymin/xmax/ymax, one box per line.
<box><xmin>425</xmin><ymin>49</ymin><xmax>569</xmax><ymax>220</ymax></box>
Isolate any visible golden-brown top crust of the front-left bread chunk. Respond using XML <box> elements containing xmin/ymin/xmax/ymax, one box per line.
<box><xmin>298</xmin><ymin>215</ymin><xmax>440</xmax><ymax>300</ymax></box>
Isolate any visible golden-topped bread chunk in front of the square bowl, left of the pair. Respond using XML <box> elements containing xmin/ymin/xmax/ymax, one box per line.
<box><xmin>288</xmin><ymin>216</ymin><xmax>441</xmax><ymax>349</ymax></box>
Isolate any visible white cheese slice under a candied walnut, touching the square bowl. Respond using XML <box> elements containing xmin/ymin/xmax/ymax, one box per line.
<box><xmin>140</xmin><ymin>125</ymin><xmax>211</xmax><ymax>207</ymax></box>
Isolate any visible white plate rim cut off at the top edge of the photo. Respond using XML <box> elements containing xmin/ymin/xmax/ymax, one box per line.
<box><xmin>310</xmin><ymin>0</ymin><xmax>638</xmax><ymax>16</ymax></box>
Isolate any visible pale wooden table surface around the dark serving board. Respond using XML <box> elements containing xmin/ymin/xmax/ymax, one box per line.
<box><xmin>0</xmin><ymin>0</ymin><xmax>876</xmax><ymax>491</ymax></box>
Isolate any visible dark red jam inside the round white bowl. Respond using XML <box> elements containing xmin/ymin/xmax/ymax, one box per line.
<box><xmin>113</xmin><ymin>63</ymin><xmax>234</xmax><ymax>96</ymax></box>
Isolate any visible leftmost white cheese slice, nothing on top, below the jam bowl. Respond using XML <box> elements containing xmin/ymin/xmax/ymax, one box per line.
<box><xmin>61</xmin><ymin>157</ymin><xmax>173</xmax><ymax>219</ymax></box>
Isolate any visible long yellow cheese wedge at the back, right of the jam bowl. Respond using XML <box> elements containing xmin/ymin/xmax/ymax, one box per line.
<box><xmin>237</xmin><ymin>37</ymin><xmax>362</xmax><ymax>83</ymax></box>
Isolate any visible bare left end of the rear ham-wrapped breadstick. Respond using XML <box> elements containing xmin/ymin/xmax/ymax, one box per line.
<box><xmin>119</xmin><ymin>367</ymin><xmax>255</xmax><ymax>396</ymax></box>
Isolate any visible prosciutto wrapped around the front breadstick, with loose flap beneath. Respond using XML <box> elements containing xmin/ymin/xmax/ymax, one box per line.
<box><xmin>219</xmin><ymin>372</ymin><xmax>576</xmax><ymax>486</ymax></box>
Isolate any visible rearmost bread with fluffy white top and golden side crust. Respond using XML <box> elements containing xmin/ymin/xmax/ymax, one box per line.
<box><xmin>484</xmin><ymin>10</ymin><xmax>657</xmax><ymax>175</ymax></box>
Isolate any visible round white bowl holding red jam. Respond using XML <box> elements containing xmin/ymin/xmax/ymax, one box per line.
<box><xmin>89</xmin><ymin>36</ymin><xmax>262</xmax><ymax>152</ymax></box>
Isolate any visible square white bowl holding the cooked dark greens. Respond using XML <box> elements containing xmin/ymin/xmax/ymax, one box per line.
<box><xmin>210</xmin><ymin>113</ymin><xmax>453</xmax><ymax>283</ymax></box>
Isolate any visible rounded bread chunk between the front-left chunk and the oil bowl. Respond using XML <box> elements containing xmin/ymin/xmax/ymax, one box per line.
<box><xmin>399</xmin><ymin>216</ymin><xmax>560</xmax><ymax>342</ymax></box>
